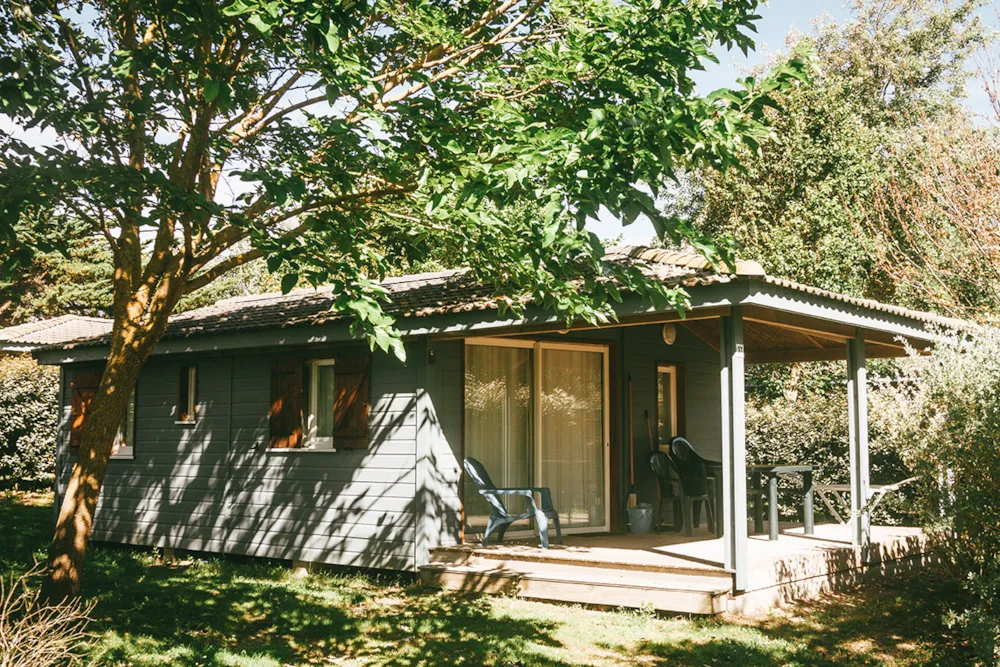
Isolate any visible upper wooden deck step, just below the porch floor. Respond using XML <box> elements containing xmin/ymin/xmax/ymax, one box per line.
<box><xmin>430</xmin><ymin>544</ymin><xmax>733</xmax><ymax>582</ymax></box>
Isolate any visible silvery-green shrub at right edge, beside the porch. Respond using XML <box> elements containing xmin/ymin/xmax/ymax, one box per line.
<box><xmin>891</xmin><ymin>329</ymin><xmax>1000</xmax><ymax>665</ymax></box>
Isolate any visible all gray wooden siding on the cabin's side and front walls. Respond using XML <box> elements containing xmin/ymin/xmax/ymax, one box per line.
<box><xmin>52</xmin><ymin>325</ymin><xmax>721</xmax><ymax>570</ymax></box>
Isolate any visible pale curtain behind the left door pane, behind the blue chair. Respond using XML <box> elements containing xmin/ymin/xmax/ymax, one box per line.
<box><xmin>465</xmin><ymin>345</ymin><xmax>535</xmax><ymax>534</ymax></box>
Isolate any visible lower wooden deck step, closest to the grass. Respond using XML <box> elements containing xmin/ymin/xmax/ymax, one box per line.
<box><xmin>420</xmin><ymin>561</ymin><xmax>730</xmax><ymax>614</ymax></box>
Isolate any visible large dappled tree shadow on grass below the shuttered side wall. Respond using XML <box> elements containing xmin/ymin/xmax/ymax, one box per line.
<box><xmin>85</xmin><ymin>546</ymin><xmax>563</xmax><ymax>667</ymax></box>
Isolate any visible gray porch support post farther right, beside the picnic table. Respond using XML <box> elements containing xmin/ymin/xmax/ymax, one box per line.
<box><xmin>847</xmin><ymin>329</ymin><xmax>871</xmax><ymax>562</ymax></box>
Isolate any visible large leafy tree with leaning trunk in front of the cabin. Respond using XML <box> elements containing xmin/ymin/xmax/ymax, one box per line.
<box><xmin>0</xmin><ymin>0</ymin><xmax>807</xmax><ymax>597</ymax></box>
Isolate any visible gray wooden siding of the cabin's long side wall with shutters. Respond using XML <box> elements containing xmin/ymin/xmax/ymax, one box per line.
<box><xmin>59</xmin><ymin>345</ymin><xmax>422</xmax><ymax>570</ymax></box>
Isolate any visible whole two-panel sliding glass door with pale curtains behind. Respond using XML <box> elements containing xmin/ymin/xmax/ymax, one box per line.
<box><xmin>465</xmin><ymin>339</ymin><xmax>610</xmax><ymax>534</ymax></box>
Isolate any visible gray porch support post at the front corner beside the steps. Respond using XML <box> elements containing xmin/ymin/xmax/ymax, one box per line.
<box><xmin>719</xmin><ymin>306</ymin><xmax>748</xmax><ymax>592</ymax></box>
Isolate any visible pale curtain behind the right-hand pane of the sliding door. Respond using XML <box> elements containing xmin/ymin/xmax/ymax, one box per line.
<box><xmin>539</xmin><ymin>348</ymin><xmax>606</xmax><ymax>528</ymax></box>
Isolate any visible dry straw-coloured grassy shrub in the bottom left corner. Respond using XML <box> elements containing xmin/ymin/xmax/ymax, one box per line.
<box><xmin>0</xmin><ymin>569</ymin><xmax>93</xmax><ymax>667</ymax></box>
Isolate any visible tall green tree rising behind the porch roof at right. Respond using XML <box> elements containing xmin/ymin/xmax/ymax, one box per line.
<box><xmin>672</xmin><ymin>0</ymin><xmax>987</xmax><ymax>308</ymax></box>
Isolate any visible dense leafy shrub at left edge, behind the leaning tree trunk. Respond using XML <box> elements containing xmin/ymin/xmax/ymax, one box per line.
<box><xmin>0</xmin><ymin>357</ymin><xmax>59</xmax><ymax>487</ymax></box>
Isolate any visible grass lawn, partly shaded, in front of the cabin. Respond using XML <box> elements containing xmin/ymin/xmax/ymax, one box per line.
<box><xmin>0</xmin><ymin>494</ymin><xmax>972</xmax><ymax>667</ymax></box>
